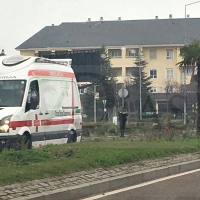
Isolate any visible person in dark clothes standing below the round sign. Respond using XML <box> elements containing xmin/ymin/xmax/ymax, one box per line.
<box><xmin>118</xmin><ymin>106</ymin><xmax>128</xmax><ymax>137</ymax></box>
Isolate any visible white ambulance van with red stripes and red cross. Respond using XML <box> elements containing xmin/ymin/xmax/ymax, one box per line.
<box><xmin>0</xmin><ymin>56</ymin><xmax>82</xmax><ymax>148</ymax></box>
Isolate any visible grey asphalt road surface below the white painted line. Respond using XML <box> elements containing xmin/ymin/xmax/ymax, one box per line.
<box><xmin>85</xmin><ymin>171</ymin><xmax>200</xmax><ymax>200</ymax></box>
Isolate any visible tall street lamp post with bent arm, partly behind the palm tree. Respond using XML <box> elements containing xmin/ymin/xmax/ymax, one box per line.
<box><xmin>183</xmin><ymin>1</ymin><xmax>200</xmax><ymax>124</ymax></box>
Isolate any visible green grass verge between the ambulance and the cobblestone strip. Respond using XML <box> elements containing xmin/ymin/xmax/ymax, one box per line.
<box><xmin>0</xmin><ymin>139</ymin><xmax>200</xmax><ymax>185</ymax></box>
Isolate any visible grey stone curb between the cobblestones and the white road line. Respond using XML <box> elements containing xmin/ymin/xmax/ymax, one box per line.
<box><xmin>13</xmin><ymin>159</ymin><xmax>200</xmax><ymax>200</ymax></box>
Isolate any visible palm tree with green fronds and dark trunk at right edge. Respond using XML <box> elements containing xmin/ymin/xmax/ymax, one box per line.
<box><xmin>177</xmin><ymin>40</ymin><xmax>200</xmax><ymax>136</ymax></box>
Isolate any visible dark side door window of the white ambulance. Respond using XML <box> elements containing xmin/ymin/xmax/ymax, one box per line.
<box><xmin>25</xmin><ymin>80</ymin><xmax>40</xmax><ymax>112</ymax></box>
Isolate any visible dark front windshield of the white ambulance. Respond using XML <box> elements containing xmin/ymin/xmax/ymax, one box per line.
<box><xmin>0</xmin><ymin>80</ymin><xmax>26</xmax><ymax>107</ymax></box>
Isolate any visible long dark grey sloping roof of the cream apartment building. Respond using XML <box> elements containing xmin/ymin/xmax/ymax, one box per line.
<box><xmin>16</xmin><ymin>18</ymin><xmax>200</xmax><ymax>50</ymax></box>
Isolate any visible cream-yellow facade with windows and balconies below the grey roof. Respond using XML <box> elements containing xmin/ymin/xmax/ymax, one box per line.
<box><xmin>108</xmin><ymin>45</ymin><xmax>184</xmax><ymax>93</ymax></box>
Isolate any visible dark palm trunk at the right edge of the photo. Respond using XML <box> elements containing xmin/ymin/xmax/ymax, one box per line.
<box><xmin>197</xmin><ymin>57</ymin><xmax>200</xmax><ymax>137</ymax></box>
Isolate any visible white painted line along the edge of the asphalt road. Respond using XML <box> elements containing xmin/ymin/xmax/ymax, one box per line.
<box><xmin>82</xmin><ymin>169</ymin><xmax>200</xmax><ymax>200</ymax></box>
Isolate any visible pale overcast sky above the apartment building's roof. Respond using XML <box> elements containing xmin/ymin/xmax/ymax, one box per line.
<box><xmin>0</xmin><ymin>0</ymin><xmax>200</xmax><ymax>55</ymax></box>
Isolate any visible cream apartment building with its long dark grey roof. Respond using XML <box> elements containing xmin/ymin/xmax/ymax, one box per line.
<box><xmin>16</xmin><ymin>16</ymin><xmax>200</xmax><ymax>93</ymax></box>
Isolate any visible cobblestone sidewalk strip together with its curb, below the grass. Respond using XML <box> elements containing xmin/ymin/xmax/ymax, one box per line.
<box><xmin>0</xmin><ymin>153</ymin><xmax>200</xmax><ymax>200</ymax></box>
